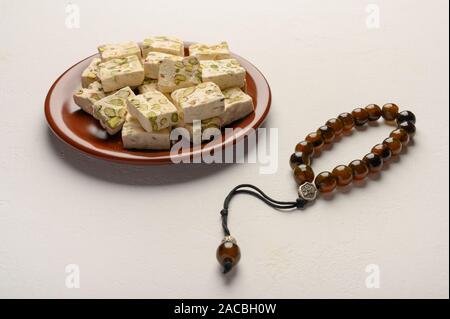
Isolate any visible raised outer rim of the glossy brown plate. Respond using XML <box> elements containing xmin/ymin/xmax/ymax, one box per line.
<box><xmin>44</xmin><ymin>49</ymin><xmax>272</xmax><ymax>165</ymax></box>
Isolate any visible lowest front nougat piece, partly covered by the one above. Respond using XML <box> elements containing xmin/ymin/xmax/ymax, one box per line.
<box><xmin>122</xmin><ymin>113</ymin><xmax>170</xmax><ymax>150</ymax></box>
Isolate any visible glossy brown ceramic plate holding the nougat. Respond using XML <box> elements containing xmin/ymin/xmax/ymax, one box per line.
<box><xmin>45</xmin><ymin>43</ymin><xmax>271</xmax><ymax>164</ymax></box>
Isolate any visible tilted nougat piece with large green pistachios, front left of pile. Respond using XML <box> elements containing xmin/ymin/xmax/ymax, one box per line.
<box><xmin>93</xmin><ymin>87</ymin><xmax>135</xmax><ymax>135</ymax></box>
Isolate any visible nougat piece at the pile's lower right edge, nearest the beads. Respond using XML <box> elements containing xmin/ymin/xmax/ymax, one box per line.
<box><xmin>219</xmin><ymin>87</ymin><xmax>254</xmax><ymax>126</ymax></box>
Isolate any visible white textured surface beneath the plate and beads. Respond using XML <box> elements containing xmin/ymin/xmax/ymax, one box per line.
<box><xmin>0</xmin><ymin>0</ymin><xmax>449</xmax><ymax>298</ymax></box>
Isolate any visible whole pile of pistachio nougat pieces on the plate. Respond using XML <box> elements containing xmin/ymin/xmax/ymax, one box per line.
<box><xmin>73</xmin><ymin>36</ymin><xmax>254</xmax><ymax>150</ymax></box>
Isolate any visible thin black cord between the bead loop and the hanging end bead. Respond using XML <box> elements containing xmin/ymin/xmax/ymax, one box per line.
<box><xmin>220</xmin><ymin>184</ymin><xmax>306</xmax><ymax>236</ymax></box>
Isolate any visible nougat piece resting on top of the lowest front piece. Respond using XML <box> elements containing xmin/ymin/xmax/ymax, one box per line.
<box><xmin>127</xmin><ymin>91</ymin><xmax>180</xmax><ymax>132</ymax></box>
